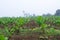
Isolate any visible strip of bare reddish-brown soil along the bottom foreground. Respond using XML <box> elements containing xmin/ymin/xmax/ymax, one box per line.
<box><xmin>9</xmin><ymin>35</ymin><xmax>48</xmax><ymax>40</ymax></box>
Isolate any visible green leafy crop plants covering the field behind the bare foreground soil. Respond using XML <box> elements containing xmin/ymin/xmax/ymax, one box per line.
<box><xmin>0</xmin><ymin>16</ymin><xmax>60</xmax><ymax>40</ymax></box>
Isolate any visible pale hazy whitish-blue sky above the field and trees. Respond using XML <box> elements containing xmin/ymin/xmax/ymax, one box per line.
<box><xmin>0</xmin><ymin>0</ymin><xmax>60</xmax><ymax>17</ymax></box>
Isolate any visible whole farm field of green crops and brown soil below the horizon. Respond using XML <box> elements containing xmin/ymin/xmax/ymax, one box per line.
<box><xmin>0</xmin><ymin>16</ymin><xmax>60</xmax><ymax>40</ymax></box>
